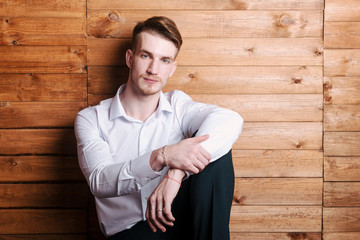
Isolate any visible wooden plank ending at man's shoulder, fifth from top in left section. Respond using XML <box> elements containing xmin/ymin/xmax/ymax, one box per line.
<box><xmin>0</xmin><ymin>102</ymin><xmax>87</xmax><ymax>128</ymax></box>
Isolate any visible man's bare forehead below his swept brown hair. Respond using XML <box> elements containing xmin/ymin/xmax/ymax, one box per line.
<box><xmin>136</xmin><ymin>32</ymin><xmax>178</xmax><ymax>59</ymax></box>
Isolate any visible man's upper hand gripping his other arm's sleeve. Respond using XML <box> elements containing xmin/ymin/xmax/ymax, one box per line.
<box><xmin>165</xmin><ymin>135</ymin><xmax>211</xmax><ymax>174</ymax></box>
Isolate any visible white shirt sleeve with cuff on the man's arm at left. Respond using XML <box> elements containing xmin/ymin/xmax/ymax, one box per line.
<box><xmin>74</xmin><ymin>111</ymin><xmax>160</xmax><ymax>198</ymax></box>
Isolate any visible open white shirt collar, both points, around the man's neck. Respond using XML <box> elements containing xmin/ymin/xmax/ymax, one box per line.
<box><xmin>110</xmin><ymin>84</ymin><xmax>173</xmax><ymax>120</ymax></box>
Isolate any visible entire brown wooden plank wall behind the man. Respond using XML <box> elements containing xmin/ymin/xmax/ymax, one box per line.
<box><xmin>0</xmin><ymin>0</ymin><xmax>360</xmax><ymax>240</ymax></box>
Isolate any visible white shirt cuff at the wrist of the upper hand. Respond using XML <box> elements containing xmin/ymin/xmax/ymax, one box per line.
<box><xmin>130</xmin><ymin>152</ymin><xmax>161</xmax><ymax>186</ymax></box>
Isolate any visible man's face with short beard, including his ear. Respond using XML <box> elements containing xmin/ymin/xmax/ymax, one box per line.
<box><xmin>126</xmin><ymin>32</ymin><xmax>178</xmax><ymax>96</ymax></box>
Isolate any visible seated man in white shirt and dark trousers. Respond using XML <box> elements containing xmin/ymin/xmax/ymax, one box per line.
<box><xmin>75</xmin><ymin>17</ymin><xmax>243</xmax><ymax>240</ymax></box>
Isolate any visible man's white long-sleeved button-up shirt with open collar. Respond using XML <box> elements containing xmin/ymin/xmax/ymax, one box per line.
<box><xmin>75</xmin><ymin>85</ymin><xmax>243</xmax><ymax>236</ymax></box>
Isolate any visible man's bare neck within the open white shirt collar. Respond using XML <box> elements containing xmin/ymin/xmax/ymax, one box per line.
<box><xmin>119</xmin><ymin>86</ymin><xmax>160</xmax><ymax>122</ymax></box>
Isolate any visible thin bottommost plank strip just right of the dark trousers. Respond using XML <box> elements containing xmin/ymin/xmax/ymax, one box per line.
<box><xmin>230</xmin><ymin>232</ymin><xmax>320</xmax><ymax>240</ymax></box>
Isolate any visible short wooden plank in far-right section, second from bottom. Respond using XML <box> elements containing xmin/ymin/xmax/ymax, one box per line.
<box><xmin>323</xmin><ymin>207</ymin><xmax>360</xmax><ymax>233</ymax></box>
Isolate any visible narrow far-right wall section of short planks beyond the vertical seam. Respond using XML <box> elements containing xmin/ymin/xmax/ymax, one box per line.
<box><xmin>323</xmin><ymin>0</ymin><xmax>360</xmax><ymax>240</ymax></box>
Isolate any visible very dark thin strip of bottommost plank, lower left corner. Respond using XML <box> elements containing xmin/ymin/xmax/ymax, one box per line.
<box><xmin>0</xmin><ymin>233</ymin><xmax>87</xmax><ymax>240</ymax></box>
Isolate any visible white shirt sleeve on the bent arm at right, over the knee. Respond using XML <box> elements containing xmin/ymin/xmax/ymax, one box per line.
<box><xmin>173</xmin><ymin>91</ymin><xmax>243</xmax><ymax>162</ymax></box>
